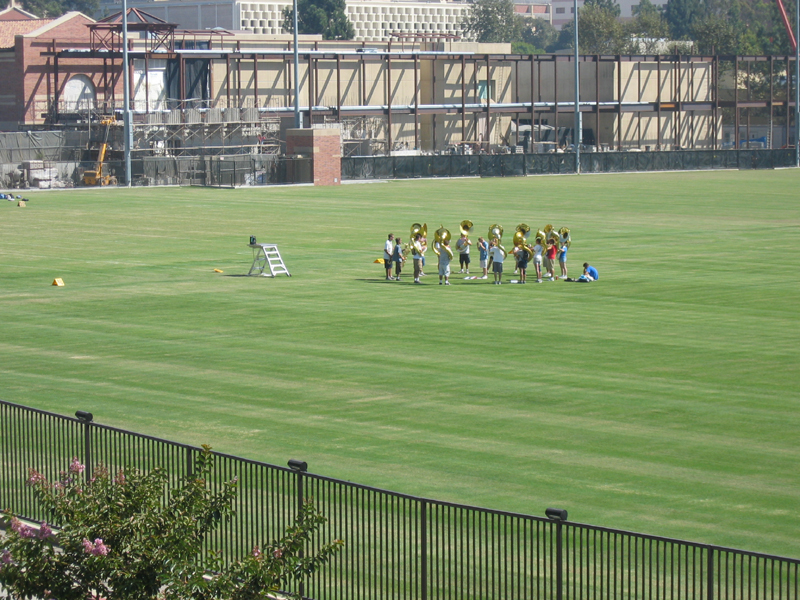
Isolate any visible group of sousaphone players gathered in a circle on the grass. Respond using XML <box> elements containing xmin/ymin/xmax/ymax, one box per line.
<box><xmin>384</xmin><ymin>220</ymin><xmax>597</xmax><ymax>285</ymax></box>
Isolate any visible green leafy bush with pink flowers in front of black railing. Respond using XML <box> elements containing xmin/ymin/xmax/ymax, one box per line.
<box><xmin>0</xmin><ymin>446</ymin><xmax>343</xmax><ymax>600</ymax></box>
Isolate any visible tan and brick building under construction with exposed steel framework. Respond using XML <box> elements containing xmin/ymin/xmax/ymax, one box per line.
<box><xmin>0</xmin><ymin>9</ymin><xmax>794</xmax><ymax>185</ymax></box>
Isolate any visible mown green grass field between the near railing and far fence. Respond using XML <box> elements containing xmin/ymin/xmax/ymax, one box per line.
<box><xmin>0</xmin><ymin>170</ymin><xmax>800</xmax><ymax>557</ymax></box>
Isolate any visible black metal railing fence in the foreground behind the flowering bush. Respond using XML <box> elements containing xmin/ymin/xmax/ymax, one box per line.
<box><xmin>0</xmin><ymin>401</ymin><xmax>800</xmax><ymax>600</ymax></box>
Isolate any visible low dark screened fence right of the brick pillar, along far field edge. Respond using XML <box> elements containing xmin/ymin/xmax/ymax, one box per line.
<box><xmin>342</xmin><ymin>148</ymin><xmax>795</xmax><ymax>180</ymax></box>
